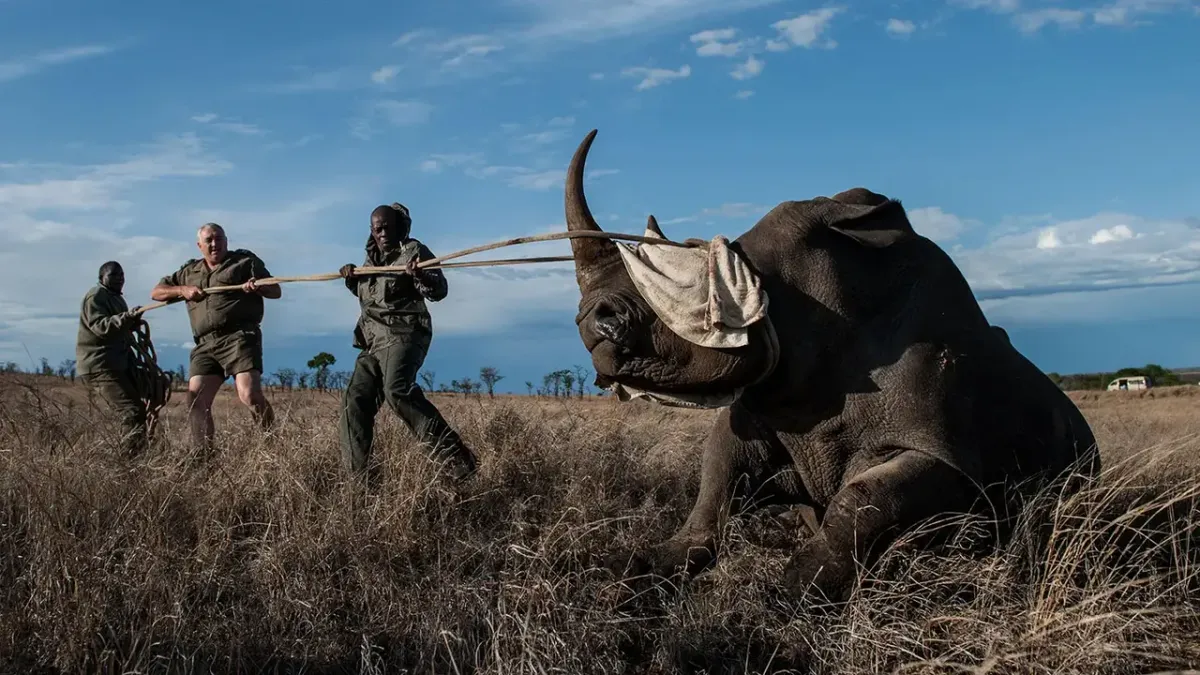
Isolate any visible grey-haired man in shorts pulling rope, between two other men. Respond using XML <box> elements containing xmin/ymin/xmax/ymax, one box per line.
<box><xmin>150</xmin><ymin>222</ymin><xmax>282</xmax><ymax>447</ymax></box>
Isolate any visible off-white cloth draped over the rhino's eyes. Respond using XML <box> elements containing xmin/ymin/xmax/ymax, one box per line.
<box><xmin>617</xmin><ymin>228</ymin><xmax>767</xmax><ymax>348</ymax></box>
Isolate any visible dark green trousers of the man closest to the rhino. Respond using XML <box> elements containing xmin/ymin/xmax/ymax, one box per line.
<box><xmin>338</xmin><ymin>340</ymin><xmax>475</xmax><ymax>479</ymax></box>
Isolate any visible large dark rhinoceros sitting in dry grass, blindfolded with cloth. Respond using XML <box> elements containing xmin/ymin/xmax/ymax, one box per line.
<box><xmin>565</xmin><ymin>130</ymin><xmax>1100</xmax><ymax>604</ymax></box>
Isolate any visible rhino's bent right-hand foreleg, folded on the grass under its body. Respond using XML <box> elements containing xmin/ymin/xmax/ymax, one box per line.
<box><xmin>784</xmin><ymin>450</ymin><xmax>979</xmax><ymax>605</ymax></box>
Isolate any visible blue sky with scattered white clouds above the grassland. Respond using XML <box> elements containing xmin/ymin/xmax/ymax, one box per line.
<box><xmin>0</xmin><ymin>0</ymin><xmax>1200</xmax><ymax>390</ymax></box>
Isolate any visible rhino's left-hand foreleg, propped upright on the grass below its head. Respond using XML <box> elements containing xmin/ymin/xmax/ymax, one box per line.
<box><xmin>606</xmin><ymin>408</ymin><xmax>804</xmax><ymax>578</ymax></box>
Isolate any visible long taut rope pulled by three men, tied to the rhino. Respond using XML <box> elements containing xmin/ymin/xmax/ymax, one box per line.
<box><xmin>138</xmin><ymin>229</ymin><xmax>706</xmax><ymax>315</ymax></box>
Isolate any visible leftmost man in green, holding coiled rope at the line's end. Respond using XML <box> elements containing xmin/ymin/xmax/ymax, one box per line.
<box><xmin>76</xmin><ymin>261</ymin><xmax>150</xmax><ymax>456</ymax></box>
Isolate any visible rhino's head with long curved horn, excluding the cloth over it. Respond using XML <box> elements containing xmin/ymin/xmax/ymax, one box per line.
<box><xmin>565</xmin><ymin>130</ymin><xmax>778</xmax><ymax>407</ymax></box>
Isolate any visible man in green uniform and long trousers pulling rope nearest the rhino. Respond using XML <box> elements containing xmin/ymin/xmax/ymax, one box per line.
<box><xmin>338</xmin><ymin>203</ymin><xmax>475</xmax><ymax>480</ymax></box>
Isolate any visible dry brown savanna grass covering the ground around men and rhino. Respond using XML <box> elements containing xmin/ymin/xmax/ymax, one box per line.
<box><xmin>0</xmin><ymin>375</ymin><xmax>1200</xmax><ymax>674</ymax></box>
